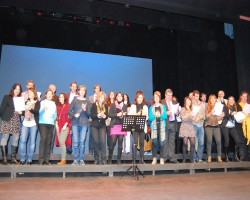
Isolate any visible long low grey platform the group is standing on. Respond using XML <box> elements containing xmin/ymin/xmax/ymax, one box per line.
<box><xmin>0</xmin><ymin>161</ymin><xmax>250</xmax><ymax>178</ymax></box>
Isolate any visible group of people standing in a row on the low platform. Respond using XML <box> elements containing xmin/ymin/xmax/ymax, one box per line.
<box><xmin>0</xmin><ymin>80</ymin><xmax>250</xmax><ymax>165</ymax></box>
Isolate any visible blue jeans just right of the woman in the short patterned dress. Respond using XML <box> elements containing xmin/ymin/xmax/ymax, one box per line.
<box><xmin>194</xmin><ymin>125</ymin><xmax>204</xmax><ymax>160</ymax></box>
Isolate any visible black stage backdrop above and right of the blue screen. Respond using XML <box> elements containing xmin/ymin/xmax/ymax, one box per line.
<box><xmin>0</xmin><ymin>16</ymin><xmax>239</xmax><ymax>102</ymax></box>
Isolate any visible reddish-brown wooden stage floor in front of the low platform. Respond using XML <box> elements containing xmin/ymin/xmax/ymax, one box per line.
<box><xmin>0</xmin><ymin>170</ymin><xmax>250</xmax><ymax>200</ymax></box>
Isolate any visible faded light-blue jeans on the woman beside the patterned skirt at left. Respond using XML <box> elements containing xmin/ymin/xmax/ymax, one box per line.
<box><xmin>19</xmin><ymin>126</ymin><xmax>37</xmax><ymax>162</ymax></box>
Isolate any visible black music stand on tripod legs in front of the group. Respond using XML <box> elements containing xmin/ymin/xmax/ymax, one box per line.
<box><xmin>121</xmin><ymin>115</ymin><xmax>146</xmax><ymax>180</ymax></box>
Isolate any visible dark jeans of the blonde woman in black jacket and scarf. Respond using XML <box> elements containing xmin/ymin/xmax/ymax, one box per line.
<box><xmin>91</xmin><ymin>127</ymin><xmax>106</xmax><ymax>161</ymax></box>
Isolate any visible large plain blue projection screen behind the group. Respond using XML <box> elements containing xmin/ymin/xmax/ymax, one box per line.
<box><xmin>0</xmin><ymin>45</ymin><xmax>153</xmax><ymax>154</ymax></box>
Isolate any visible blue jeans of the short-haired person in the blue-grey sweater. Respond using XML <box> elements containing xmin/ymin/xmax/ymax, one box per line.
<box><xmin>72</xmin><ymin>126</ymin><xmax>88</xmax><ymax>161</ymax></box>
